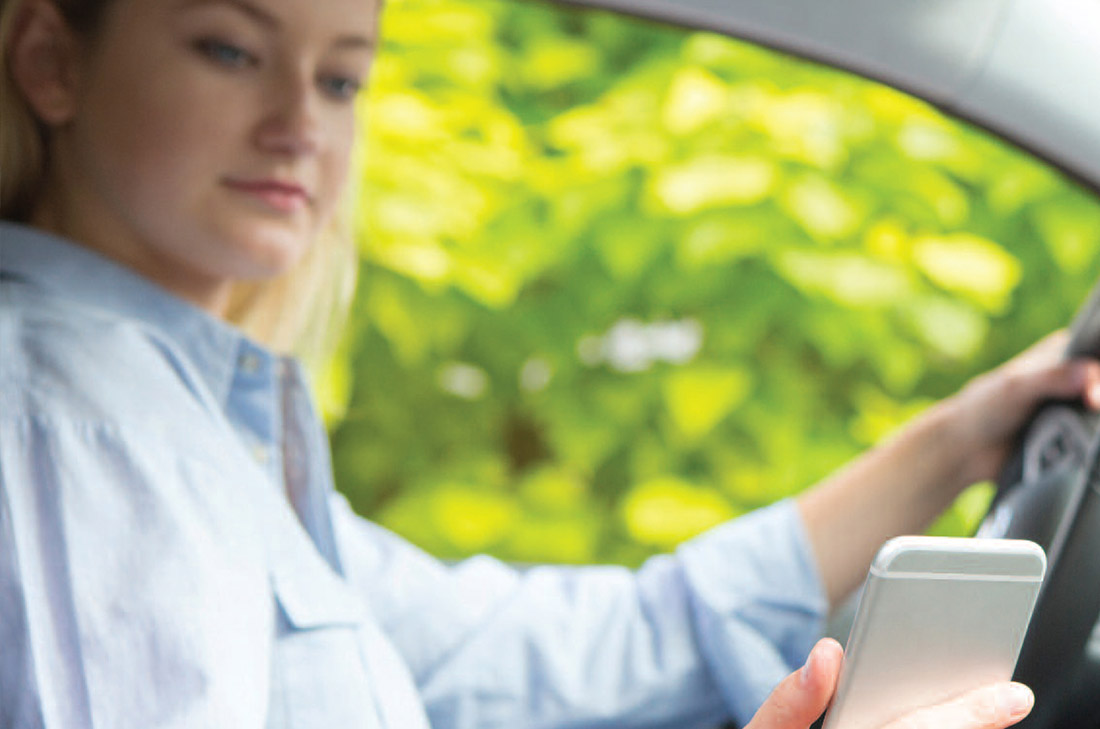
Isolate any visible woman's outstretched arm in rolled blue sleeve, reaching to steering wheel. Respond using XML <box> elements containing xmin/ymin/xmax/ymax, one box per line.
<box><xmin>332</xmin><ymin>340</ymin><xmax>1100</xmax><ymax>729</ymax></box>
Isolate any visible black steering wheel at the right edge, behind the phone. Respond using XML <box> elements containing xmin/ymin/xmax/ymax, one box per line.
<box><xmin>978</xmin><ymin>277</ymin><xmax>1100</xmax><ymax>729</ymax></box>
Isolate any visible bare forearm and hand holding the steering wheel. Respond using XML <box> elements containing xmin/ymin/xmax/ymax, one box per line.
<box><xmin>799</xmin><ymin>332</ymin><xmax>1100</xmax><ymax>605</ymax></box>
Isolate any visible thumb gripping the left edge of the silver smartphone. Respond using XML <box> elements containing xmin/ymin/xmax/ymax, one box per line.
<box><xmin>745</xmin><ymin>638</ymin><xmax>844</xmax><ymax>729</ymax></box>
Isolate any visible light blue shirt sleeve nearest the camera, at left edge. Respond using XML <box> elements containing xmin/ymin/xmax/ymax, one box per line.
<box><xmin>0</xmin><ymin>417</ymin><xmax>274</xmax><ymax>729</ymax></box>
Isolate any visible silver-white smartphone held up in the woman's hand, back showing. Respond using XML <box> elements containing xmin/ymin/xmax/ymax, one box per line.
<box><xmin>822</xmin><ymin>537</ymin><xmax>1046</xmax><ymax>729</ymax></box>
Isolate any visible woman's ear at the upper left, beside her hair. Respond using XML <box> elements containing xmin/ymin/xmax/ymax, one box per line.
<box><xmin>8</xmin><ymin>0</ymin><xmax>80</xmax><ymax>126</ymax></box>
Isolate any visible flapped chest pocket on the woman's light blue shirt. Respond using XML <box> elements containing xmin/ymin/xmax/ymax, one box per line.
<box><xmin>267</xmin><ymin>545</ymin><xmax>381</xmax><ymax>729</ymax></box>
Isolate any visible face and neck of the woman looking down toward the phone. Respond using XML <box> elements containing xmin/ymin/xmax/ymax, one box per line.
<box><xmin>32</xmin><ymin>0</ymin><xmax>376</xmax><ymax>309</ymax></box>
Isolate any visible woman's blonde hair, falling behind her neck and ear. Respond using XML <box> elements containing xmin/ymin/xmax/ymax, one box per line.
<box><xmin>0</xmin><ymin>0</ymin><xmax>361</xmax><ymax>361</ymax></box>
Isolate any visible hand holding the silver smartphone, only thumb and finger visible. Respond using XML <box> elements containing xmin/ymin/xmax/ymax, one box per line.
<box><xmin>745</xmin><ymin>638</ymin><xmax>1035</xmax><ymax>729</ymax></box>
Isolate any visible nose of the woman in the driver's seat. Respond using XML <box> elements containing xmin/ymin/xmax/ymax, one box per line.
<box><xmin>255</xmin><ymin>73</ymin><xmax>321</xmax><ymax>157</ymax></box>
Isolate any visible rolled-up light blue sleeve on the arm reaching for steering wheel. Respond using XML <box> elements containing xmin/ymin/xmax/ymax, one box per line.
<box><xmin>333</xmin><ymin>496</ymin><xmax>826</xmax><ymax>729</ymax></box>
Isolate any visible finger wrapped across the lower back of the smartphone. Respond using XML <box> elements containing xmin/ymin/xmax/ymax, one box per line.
<box><xmin>886</xmin><ymin>683</ymin><xmax>1035</xmax><ymax>729</ymax></box>
